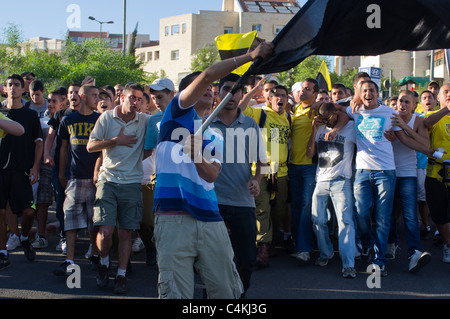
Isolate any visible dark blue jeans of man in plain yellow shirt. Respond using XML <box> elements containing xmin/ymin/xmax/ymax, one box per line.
<box><xmin>288</xmin><ymin>164</ymin><xmax>317</xmax><ymax>252</ymax></box>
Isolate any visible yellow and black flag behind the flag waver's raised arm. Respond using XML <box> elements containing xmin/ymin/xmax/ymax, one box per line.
<box><xmin>215</xmin><ymin>31</ymin><xmax>256</xmax><ymax>75</ymax></box>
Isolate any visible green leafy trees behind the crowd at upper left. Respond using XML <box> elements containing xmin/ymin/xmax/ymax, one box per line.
<box><xmin>0</xmin><ymin>23</ymin><xmax>156</xmax><ymax>93</ymax></box>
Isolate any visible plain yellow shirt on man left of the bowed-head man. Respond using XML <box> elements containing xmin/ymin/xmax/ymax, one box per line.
<box><xmin>289</xmin><ymin>104</ymin><xmax>314</xmax><ymax>165</ymax></box>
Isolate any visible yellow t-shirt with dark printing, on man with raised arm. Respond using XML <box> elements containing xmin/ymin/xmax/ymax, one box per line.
<box><xmin>244</xmin><ymin>105</ymin><xmax>291</xmax><ymax>177</ymax></box>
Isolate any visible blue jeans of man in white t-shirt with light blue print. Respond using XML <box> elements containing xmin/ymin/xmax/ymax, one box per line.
<box><xmin>354</xmin><ymin>169</ymin><xmax>395</xmax><ymax>266</ymax></box>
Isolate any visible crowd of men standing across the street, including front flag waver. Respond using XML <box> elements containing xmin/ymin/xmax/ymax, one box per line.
<box><xmin>0</xmin><ymin>42</ymin><xmax>450</xmax><ymax>299</ymax></box>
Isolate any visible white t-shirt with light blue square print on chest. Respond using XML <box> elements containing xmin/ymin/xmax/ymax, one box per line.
<box><xmin>346</xmin><ymin>105</ymin><xmax>400</xmax><ymax>170</ymax></box>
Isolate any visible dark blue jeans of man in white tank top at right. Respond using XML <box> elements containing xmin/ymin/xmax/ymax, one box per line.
<box><xmin>388</xmin><ymin>177</ymin><xmax>423</xmax><ymax>257</ymax></box>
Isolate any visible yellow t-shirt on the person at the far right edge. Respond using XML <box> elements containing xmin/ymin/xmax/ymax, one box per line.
<box><xmin>426</xmin><ymin>111</ymin><xmax>450</xmax><ymax>181</ymax></box>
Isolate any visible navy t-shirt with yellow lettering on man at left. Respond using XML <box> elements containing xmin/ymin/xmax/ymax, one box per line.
<box><xmin>58</xmin><ymin>112</ymin><xmax>101</xmax><ymax>179</ymax></box>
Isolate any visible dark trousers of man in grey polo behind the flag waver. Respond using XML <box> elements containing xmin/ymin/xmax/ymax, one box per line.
<box><xmin>219</xmin><ymin>205</ymin><xmax>256</xmax><ymax>292</ymax></box>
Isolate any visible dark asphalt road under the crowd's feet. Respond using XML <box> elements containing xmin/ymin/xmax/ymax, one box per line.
<box><xmin>0</xmin><ymin>209</ymin><xmax>450</xmax><ymax>310</ymax></box>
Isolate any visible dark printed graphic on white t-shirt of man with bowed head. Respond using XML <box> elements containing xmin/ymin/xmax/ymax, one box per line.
<box><xmin>317</xmin><ymin>134</ymin><xmax>345</xmax><ymax>168</ymax></box>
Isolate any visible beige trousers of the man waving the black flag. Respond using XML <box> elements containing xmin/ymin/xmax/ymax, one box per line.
<box><xmin>155</xmin><ymin>214</ymin><xmax>243</xmax><ymax>299</ymax></box>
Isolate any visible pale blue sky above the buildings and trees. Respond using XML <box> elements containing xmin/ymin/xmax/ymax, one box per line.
<box><xmin>0</xmin><ymin>0</ymin><xmax>306</xmax><ymax>42</ymax></box>
